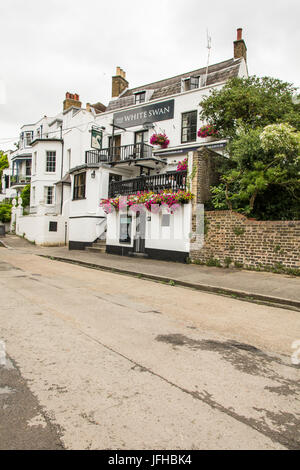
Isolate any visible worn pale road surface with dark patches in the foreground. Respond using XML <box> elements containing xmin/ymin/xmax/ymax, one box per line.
<box><xmin>0</xmin><ymin>248</ymin><xmax>300</xmax><ymax>449</ymax></box>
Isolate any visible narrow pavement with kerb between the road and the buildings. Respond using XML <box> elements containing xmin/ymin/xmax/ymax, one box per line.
<box><xmin>0</xmin><ymin>235</ymin><xmax>300</xmax><ymax>310</ymax></box>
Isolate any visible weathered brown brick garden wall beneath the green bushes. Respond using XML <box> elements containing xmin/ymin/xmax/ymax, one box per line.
<box><xmin>190</xmin><ymin>211</ymin><xmax>300</xmax><ymax>269</ymax></box>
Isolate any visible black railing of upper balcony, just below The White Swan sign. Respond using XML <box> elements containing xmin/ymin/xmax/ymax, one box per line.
<box><xmin>85</xmin><ymin>142</ymin><xmax>153</xmax><ymax>164</ymax></box>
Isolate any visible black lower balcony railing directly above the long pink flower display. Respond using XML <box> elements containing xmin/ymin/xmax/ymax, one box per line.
<box><xmin>109</xmin><ymin>171</ymin><xmax>187</xmax><ymax>197</ymax></box>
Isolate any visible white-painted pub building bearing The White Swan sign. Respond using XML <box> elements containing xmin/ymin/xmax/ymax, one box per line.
<box><xmin>12</xmin><ymin>29</ymin><xmax>248</xmax><ymax>262</ymax></box>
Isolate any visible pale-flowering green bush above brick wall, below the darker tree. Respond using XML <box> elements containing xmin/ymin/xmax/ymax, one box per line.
<box><xmin>212</xmin><ymin>124</ymin><xmax>300</xmax><ymax>219</ymax></box>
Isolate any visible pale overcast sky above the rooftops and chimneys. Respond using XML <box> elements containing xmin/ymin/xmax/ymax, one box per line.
<box><xmin>0</xmin><ymin>0</ymin><xmax>300</xmax><ymax>149</ymax></box>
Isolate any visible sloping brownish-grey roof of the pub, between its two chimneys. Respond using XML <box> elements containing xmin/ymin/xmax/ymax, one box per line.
<box><xmin>106</xmin><ymin>59</ymin><xmax>242</xmax><ymax>111</ymax></box>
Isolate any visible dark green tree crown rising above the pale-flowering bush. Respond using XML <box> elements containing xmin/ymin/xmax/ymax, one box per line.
<box><xmin>200</xmin><ymin>76</ymin><xmax>300</xmax><ymax>139</ymax></box>
